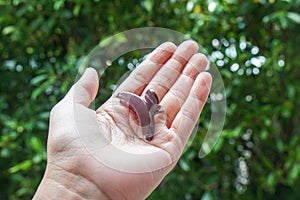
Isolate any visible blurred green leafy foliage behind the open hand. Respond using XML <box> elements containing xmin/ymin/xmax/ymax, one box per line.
<box><xmin>0</xmin><ymin>0</ymin><xmax>300</xmax><ymax>200</ymax></box>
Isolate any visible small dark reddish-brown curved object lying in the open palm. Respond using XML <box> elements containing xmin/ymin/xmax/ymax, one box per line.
<box><xmin>117</xmin><ymin>89</ymin><xmax>163</xmax><ymax>141</ymax></box>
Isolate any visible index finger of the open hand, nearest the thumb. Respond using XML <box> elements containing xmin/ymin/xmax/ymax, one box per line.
<box><xmin>115</xmin><ymin>42</ymin><xmax>177</xmax><ymax>95</ymax></box>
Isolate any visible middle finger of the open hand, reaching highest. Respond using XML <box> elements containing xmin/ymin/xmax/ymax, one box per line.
<box><xmin>144</xmin><ymin>40</ymin><xmax>198</xmax><ymax>100</ymax></box>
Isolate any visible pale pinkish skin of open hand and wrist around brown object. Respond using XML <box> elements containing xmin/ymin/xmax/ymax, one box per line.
<box><xmin>34</xmin><ymin>41</ymin><xmax>212</xmax><ymax>199</ymax></box>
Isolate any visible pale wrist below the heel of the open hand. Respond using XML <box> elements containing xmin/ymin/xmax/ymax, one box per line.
<box><xmin>33</xmin><ymin>164</ymin><xmax>108</xmax><ymax>200</ymax></box>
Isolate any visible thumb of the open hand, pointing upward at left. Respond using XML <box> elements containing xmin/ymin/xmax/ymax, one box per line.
<box><xmin>64</xmin><ymin>68</ymin><xmax>99</xmax><ymax>107</ymax></box>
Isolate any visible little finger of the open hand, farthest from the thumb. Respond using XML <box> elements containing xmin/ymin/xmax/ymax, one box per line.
<box><xmin>171</xmin><ymin>72</ymin><xmax>212</xmax><ymax>144</ymax></box>
